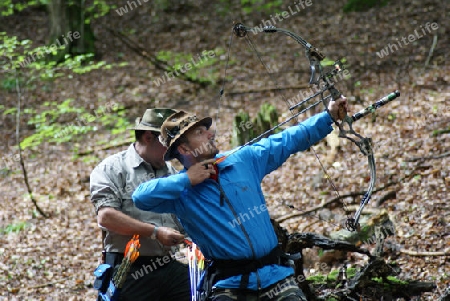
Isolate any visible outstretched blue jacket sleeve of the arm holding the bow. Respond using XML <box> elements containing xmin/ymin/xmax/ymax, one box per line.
<box><xmin>242</xmin><ymin>112</ymin><xmax>333</xmax><ymax>180</ymax></box>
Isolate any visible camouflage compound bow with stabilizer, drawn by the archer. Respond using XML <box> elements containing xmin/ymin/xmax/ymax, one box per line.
<box><xmin>216</xmin><ymin>23</ymin><xmax>400</xmax><ymax>231</ymax></box>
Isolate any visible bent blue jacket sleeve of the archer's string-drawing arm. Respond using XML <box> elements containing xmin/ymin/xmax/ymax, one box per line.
<box><xmin>132</xmin><ymin>172</ymin><xmax>191</xmax><ymax>214</ymax></box>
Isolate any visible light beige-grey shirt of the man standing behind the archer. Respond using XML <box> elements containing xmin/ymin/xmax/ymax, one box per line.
<box><xmin>90</xmin><ymin>144</ymin><xmax>182</xmax><ymax>256</ymax></box>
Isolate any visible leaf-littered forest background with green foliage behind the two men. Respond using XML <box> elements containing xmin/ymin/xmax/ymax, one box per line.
<box><xmin>0</xmin><ymin>0</ymin><xmax>450</xmax><ymax>300</ymax></box>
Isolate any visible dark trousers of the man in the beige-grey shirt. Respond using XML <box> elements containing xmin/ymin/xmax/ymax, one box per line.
<box><xmin>104</xmin><ymin>252</ymin><xmax>191</xmax><ymax>301</ymax></box>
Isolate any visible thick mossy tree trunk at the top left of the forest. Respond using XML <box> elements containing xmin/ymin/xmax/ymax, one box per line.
<box><xmin>48</xmin><ymin>0</ymin><xmax>95</xmax><ymax>62</ymax></box>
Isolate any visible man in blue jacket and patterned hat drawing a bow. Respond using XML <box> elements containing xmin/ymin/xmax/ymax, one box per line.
<box><xmin>132</xmin><ymin>97</ymin><xmax>347</xmax><ymax>301</ymax></box>
